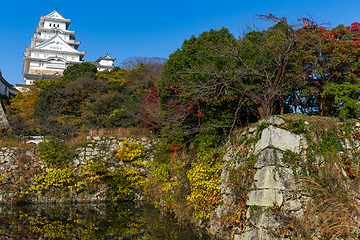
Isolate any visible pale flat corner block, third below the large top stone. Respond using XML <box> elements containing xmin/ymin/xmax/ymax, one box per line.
<box><xmin>246</xmin><ymin>189</ymin><xmax>283</xmax><ymax>207</ymax></box>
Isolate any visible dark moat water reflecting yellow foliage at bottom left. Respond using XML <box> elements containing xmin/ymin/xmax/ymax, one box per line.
<box><xmin>0</xmin><ymin>203</ymin><xmax>209</xmax><ymax>240</ymax></box>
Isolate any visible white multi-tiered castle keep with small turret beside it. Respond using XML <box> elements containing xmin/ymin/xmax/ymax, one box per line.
<box><xmin>23</xmin><ymin>7</ymin><xmax>115</xmax><ymax>84</ymax></box>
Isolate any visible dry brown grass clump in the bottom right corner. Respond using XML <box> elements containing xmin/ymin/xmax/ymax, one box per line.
<box><xmin>297</xmin><ymin>160</ymin><xmax>360</xmax><ymax>239</ymax></box>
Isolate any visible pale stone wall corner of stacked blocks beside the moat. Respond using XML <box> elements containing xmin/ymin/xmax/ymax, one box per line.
<box><xmin>209</xmin><ymin>116</ymin><xmax>320</xmax><ymax>240</ymax></box>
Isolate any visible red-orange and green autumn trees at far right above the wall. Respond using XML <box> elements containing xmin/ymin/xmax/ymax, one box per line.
<box><xmin>293</xmin><ymin>19</ymin><xmax>360</xmax><ymax>118</ymax></box>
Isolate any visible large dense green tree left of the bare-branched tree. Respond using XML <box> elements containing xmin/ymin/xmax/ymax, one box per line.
<box><xmin>157</xmin><ymin>28</ymin><xmax>237</xmax><ymax>134</ymax></box>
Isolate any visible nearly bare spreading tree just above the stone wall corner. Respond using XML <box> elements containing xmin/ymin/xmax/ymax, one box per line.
<box><xmin>216</xmin><ymin>14</ymin><xmax>302</xmax><ymax>119</ymax></box>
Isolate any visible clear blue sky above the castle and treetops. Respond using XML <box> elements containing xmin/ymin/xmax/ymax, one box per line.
<box><xmin>0</xmin><ymin>0</ymin><xmax>360</xmax><ymax>84</ymax></box>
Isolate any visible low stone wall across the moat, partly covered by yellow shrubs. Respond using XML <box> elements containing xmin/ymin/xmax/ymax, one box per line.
<box><xmin>0</xmin><ymin>136</ymin><xmax>156</xmax><ymax>204</ymax></box>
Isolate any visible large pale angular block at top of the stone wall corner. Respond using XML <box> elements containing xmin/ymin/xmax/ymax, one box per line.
<box><xmin>254</xmin><ymin>126</ymin><xmax>300</xmax><ymax>154</ymax></box>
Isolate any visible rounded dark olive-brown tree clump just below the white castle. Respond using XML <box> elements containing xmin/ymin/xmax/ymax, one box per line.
<box><xmin>35</xmin><ymin>77</ymin><xmax>114</xmax><ymax>136</ymax></box>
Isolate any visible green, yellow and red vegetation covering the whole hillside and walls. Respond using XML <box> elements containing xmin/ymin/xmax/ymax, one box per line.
<box><xmin>2</xmin><ymin>14</ymin><xmax>360</xmax><ymax>238</ymax></box>
